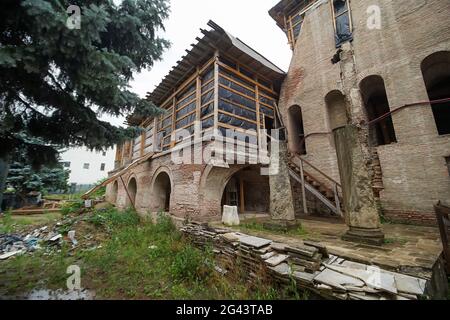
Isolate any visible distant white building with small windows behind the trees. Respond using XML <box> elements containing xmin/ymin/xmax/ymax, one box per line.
<box><xmin>61</xmin><ymin>148</ymin><xmax>116</xmax><ymax>184</ymax></box>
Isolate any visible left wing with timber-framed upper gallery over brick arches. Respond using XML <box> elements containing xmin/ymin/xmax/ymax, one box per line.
<box><xmin>103</xmin><ymin>21</ymin><xmax>285</xmax><ymax>219</ymax></box>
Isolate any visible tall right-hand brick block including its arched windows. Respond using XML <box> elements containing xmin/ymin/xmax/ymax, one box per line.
<box><xmin>270</xmin><ymin>0</ymin><xmax>450</xmax><ymax>223</ymax></box>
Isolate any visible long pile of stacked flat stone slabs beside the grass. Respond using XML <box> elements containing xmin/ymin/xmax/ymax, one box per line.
<box><xmin>181</xmin><ymin>223</ymin><xmax>428</xmax><ymax>300</ymax></box>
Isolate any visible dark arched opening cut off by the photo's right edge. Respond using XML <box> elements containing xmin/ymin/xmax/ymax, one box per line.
<box><xmin>421</xmin><ymin>51</ymin><xmax>450</xmax><ymax>135</ymax></box>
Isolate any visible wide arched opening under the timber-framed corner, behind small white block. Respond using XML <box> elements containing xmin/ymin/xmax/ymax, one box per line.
<box><xmin>221</xmin><ymin>166</ymin><xmax>270</xmax><ymax>214</ymax></box>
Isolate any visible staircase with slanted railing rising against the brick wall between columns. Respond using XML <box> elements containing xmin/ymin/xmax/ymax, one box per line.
<box><xmin>288</xmin><ymin>153</ymin><xmax>343</xmax><ymax>217</ymax></box>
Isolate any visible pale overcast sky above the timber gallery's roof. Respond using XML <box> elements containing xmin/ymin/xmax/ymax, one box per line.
<box><xmin>103</xmin><ymin>0</ymin><xmax>292</xmax><ymax>125</ymax></box>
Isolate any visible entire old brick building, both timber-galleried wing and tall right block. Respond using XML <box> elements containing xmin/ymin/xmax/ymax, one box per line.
<box><xmin>107</xmin><ymin>0</ymin><xmax>450</xmax><ymax>228</ymax></box>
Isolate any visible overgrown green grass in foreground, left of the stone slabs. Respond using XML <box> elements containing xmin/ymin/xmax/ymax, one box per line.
<box><xmin>0</xmin><ymin>209</ymin><xmax>307</xmax><ymax>299</ymax></box>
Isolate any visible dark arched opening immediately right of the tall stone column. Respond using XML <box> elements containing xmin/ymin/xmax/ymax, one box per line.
<box><xmin>360</xmin><ymin>75</ymin><xmax>397</xmax><ymax>146</ymax></box>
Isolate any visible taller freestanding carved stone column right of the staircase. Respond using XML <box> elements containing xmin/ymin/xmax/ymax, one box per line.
<box><xmin>333</xmin><ymin>125</ymin><xmax>384</xmax><ymax>245</ymax></box>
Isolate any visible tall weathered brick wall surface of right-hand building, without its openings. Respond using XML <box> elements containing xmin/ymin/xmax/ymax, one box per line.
<box><xmin>279</xmin><ymin>0</ymin><xmax>450</xmax><ymax>224</ymax></box>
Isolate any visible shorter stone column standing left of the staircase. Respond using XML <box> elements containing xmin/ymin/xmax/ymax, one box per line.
<box><xmin>265</xmin><ymin>141</ymin><xmax>300</xmax><ymax>230</ymax></box>
